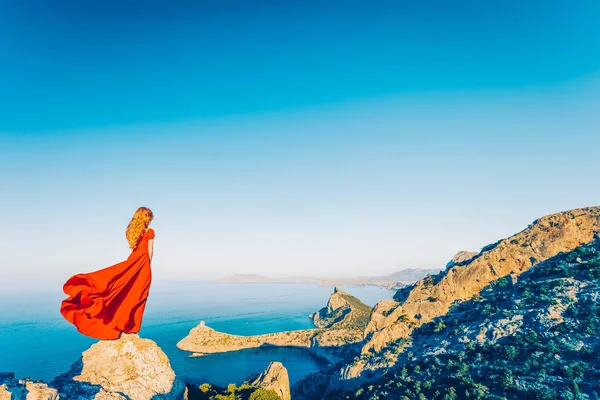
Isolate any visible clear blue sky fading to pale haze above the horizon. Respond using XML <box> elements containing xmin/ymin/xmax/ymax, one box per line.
<box><xmin>0</xmin><ymin>0</ymin><xmax>600</xmax><ymax>282</ymax></box>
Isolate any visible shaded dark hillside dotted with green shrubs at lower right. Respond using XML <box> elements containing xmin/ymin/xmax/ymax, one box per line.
<box><xmin>326</xmin><ymin>239</ymin><xmax>600</xmax><ymax>400</ymax></box>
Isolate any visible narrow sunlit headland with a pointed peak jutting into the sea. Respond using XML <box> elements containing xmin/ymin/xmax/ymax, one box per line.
<box><xmin>177</xmin><ymin>288</ymin><xmax>371</xmax><ymax>363</ymax></box>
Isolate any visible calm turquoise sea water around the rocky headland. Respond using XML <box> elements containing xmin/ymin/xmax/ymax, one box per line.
<box><xmin>0</xmin><ymin>282</ymin><xmax>393</xmax><ymax>385</ymax></box>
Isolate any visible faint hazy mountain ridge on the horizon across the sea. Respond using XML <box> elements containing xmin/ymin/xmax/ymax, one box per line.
<box><xmin>219</xmin><ymin>268</ymin><xmax>440</xmax><ymax>289</ymax></box>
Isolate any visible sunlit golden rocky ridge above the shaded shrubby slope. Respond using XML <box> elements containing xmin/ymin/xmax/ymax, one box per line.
<box><xmin>339</xmin><ymin>207</ymin><xmax>600</xmax><ymax>379</ymax></box>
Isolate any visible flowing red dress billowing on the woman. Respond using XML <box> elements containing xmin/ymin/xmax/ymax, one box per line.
<box><xmin>60</xmin><ymin>229</ymin><xmax>154</xmax><ymax>340</ymax></box>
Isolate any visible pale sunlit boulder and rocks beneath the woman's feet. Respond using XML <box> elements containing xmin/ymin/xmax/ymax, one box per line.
<box><xmin>0</xmin><ymin>335</ymin><xmax>187</xmax><ymax>400</ymax></box>
